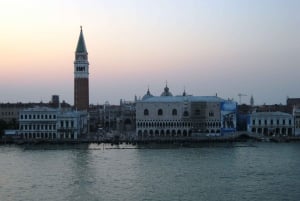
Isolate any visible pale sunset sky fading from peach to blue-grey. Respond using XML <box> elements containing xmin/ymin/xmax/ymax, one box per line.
<box><xmin>0</xmin><ymin>0</ymin><xmax>300</xmax><ymax>105</ymax></box>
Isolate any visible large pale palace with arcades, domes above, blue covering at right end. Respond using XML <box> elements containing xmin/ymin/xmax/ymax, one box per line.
<box><xmin>136</xmin><ymin>86</ymin><xmax>236</xmax><ymax>138</ymax></box>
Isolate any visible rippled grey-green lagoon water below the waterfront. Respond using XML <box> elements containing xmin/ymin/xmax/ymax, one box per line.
<box><xmin>0</xmin><ymin>143</ymin><xmax>300</xmax><ymax>201</ymax></box>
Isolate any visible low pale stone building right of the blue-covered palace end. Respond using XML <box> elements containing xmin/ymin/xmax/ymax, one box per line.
<box><xmin>247</xmin><ymin>112</ymin><xmax>294</xmax><ymax>136</ymax></box>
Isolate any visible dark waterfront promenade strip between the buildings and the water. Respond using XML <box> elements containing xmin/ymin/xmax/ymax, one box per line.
<box><xmin>0</xmin><ymin>132</ymin><xmax>300</xmax><ymax>144</ymax></box>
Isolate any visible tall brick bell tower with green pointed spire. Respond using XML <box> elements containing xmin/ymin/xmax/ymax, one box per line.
<box><xmin>74</xmin><ymin>26</ymin><xmax>89</xmax><ymax>110</ymax></box>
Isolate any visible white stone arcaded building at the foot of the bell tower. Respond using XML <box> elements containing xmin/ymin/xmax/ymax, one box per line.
<box><xmin>18</xmin><ymin>107</ymin><xmax>87</xmax><ymax>140</ymax></box>
